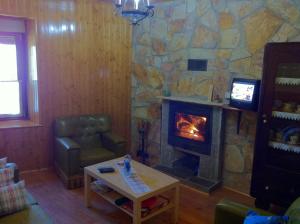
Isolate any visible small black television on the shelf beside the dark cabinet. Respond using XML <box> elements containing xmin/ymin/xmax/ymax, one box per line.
<box><xmin>229</xmin><ymin>78</ymin><xmax>260</xmax><ymax>111</ymax></box>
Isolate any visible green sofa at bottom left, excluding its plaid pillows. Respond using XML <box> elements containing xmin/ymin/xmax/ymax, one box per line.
<box><xmin>0</xmin><ymin>163</ymin><xmax>53</xmax><ymax>224</ymax></box>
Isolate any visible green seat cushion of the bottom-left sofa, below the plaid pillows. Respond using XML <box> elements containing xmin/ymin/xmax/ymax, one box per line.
<box><xmin>0</xmin><ymin>205</ymin><xmax>52</xmax><ymax>224</ymax></box>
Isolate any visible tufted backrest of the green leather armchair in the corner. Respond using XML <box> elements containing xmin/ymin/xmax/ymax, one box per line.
<box><xmin>54</xmin><ymin>114</ymin><xmax>111</xmax><ymax>138</ymax></box>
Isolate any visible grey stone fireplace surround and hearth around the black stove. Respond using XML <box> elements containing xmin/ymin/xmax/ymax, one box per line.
<box><xmin>157</xmin><ymin>97</ymin><xmax>223</xmax><ymax>192</ymax></box>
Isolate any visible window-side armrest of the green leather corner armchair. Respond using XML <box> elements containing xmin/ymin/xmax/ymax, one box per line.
<box><xmin>54</xmin><ymin>137</ymin><xmax>80</xmax><ymax>177</ymax></box>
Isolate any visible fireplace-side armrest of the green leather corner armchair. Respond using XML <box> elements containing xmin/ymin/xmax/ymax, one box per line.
<box><xmin>102</xmin><ymin>132</ymin><xmax>126</xmax><ymax>156</ymax></box>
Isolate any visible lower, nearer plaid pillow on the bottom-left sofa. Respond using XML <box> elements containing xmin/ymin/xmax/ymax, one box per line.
<box><xmin>0</xmin><ymin>181</ymin><xmax>27</xmax><ymax>215</ymax></box>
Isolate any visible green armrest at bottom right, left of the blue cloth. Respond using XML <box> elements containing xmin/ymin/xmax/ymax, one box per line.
<box><xmin>215</xmin><ymin>199</ymin><xmax>274</xmax><ymax>224</ymax></box>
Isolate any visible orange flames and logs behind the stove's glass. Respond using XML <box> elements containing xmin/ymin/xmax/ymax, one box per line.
<box><xmin>176</xmin><ymin>113</ymin><xmax>207</xmax><ymax>142</ymax></box>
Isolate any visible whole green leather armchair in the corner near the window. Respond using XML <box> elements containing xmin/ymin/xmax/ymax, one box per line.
<box><xmin>54</xmin><ymin>115</ymin><xmax>126</xmax><ymax>189</ymax></box>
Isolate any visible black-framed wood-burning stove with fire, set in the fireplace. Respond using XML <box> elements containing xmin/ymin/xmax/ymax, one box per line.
<box><xmin>168</xmin><ymin>101</ymin><xmax>212</xmax><ymax>155</ymax></box>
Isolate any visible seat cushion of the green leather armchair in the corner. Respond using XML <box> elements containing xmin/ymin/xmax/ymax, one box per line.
<box><xmin>80</xmin><ymin>148</ymin><xmax>115</xmax><ymax>168</ymax></box>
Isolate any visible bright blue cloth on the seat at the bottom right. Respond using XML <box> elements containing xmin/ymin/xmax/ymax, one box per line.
<box><xmin>244</xmin><ymin>210</ymin><xmax>289</xmax><ymax>224</ymax></box>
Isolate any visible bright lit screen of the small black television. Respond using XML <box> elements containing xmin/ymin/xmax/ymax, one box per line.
<box><xmin>231</xmin><ymin>82</ymin><xmax>255</xmax><ymax>102</ymax></box>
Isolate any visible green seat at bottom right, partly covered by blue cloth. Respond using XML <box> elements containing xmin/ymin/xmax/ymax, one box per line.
<box><xmin>215</xmin><ymin>198</ymin><xmax>300</xmax><ymax>224</ymax></box>
